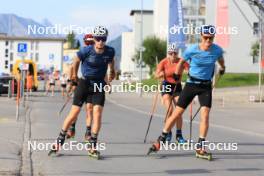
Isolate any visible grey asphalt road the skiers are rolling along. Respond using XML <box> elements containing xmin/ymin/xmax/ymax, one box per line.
<box><xmin>17</xmin><ymin>89</ymin><xmax>264</xmax><ymax>176</ymax></box>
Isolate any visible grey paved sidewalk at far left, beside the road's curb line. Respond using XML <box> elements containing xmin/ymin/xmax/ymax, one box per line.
<box><xmin>0</xmin><ymin>97</ymin><xmax>26</xmax><ymax>175</ymax></box>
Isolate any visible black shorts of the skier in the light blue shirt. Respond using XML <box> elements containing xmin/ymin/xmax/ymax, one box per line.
<box><xmin>177</xmin><ymin>83</ymin><xmax>212</xmax><ymax>109</ymax></box>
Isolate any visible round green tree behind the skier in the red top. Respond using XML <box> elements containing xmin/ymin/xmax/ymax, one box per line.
<box><xmin>134</xmin><ymin>36</ymin><xmax>167</xmax><ymax>74</ymax></box>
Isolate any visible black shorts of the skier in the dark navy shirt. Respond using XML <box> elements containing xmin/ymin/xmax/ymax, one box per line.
<box><xmin>72</xmin><ymin>79</ymin><xmax>105</xmax><ymax>107</ymax></box>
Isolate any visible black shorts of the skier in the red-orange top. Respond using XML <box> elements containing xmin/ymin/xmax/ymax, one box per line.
<box><xmin>161</xmin><ymin>81</ymin><xmax>182</xmax><ymax>97</ymax></box>
